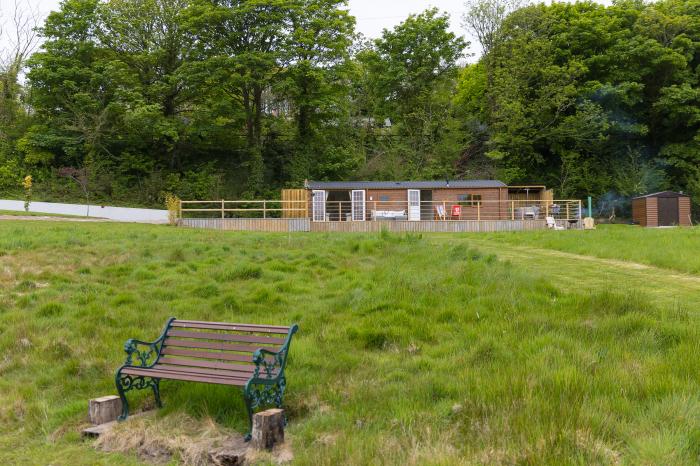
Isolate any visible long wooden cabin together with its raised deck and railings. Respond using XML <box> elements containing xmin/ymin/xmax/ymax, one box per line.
<box><xmin>178</xmin><ymin>180</ymin><xmax>582</xmax><ymax>233</ymax></box>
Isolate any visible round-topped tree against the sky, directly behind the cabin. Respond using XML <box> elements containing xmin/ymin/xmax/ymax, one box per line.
<box><xmin>359</xmin><ymin>9</ymin><xmax>468</xmax><ymax>177</ymax></box>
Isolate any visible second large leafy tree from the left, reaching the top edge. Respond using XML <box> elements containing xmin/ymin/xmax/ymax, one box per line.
<box><xmin>96</xmin><ymin>0</ymin><xmax>196</xmax><ymax>169</ymax></box>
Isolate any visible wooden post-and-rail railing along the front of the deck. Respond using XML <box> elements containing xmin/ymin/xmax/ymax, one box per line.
<box><xmin>180</xmin><ymin>199</ymin><xmax>583</xmax><ymax>223</ymax></box>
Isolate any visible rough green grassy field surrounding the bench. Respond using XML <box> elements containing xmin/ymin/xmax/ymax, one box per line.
<box><xmin>0</xmin><ymin>221</ymin><xmax>700</xmax><ymax>465</ymax></box>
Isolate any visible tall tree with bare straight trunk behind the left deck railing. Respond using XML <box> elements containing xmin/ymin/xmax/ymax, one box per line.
<box><xmin>187</xmin><ymin>0</ymin><xmax>293</xmax><ymax>195</ymax></box>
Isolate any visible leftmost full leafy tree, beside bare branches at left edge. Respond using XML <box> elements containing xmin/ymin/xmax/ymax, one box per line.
<box><xmin>26</xmin><ymin>0</ymin><xmax>116</xmax><ymax>171</ymax></box>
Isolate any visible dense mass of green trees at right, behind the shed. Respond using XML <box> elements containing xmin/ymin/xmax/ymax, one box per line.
<box><xmin>458</xmin><ymin>0</ymin><xmax>700</xmax><ymax>197</ymax></box>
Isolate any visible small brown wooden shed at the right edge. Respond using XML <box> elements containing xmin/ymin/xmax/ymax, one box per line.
<box><xmin>632</xmin><ymin>191</ymin><xmax>692</xmax><ymax>227</ymax></box>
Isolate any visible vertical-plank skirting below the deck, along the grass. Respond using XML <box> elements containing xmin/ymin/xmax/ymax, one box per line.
<box><xmin>180</xmin><ymin>218</ymin><xmax>568</xmax><ymax>233</ymax></box>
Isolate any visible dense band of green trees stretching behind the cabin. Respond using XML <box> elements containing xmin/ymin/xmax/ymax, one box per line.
<box><xmin>0</xmin><ymin>0</ymin><xmax>700</xmax><ymax>214</ymax></box>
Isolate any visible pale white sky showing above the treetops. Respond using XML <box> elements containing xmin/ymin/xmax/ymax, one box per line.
<box><xmin>0</xmin><ymin>0</ymin><xmax>612</xmax><ymax>60</ymax></box>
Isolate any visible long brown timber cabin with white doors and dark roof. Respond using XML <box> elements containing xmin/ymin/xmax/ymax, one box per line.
<box><xmin>282</xmin><ymin>180</ymin><xmax>560</xmax><ymax>222</ymax></box>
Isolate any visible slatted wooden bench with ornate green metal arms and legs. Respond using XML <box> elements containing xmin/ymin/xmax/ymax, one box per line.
<box><xmin>115</xmin><ymin>318</ymin><xmax>299</xmax><ymax>439</ymax></box>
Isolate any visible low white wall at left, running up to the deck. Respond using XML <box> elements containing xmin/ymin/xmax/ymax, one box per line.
<box><xmin>0</xmin><ymin>200</ymin><xmax>168</xmax><ymax>223</ymax></box>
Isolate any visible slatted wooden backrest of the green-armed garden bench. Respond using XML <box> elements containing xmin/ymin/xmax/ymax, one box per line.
<box><xmin>159</xmin><ymin>320</ymin><xmax>296</xmax><ymax>372</ymax></box>
